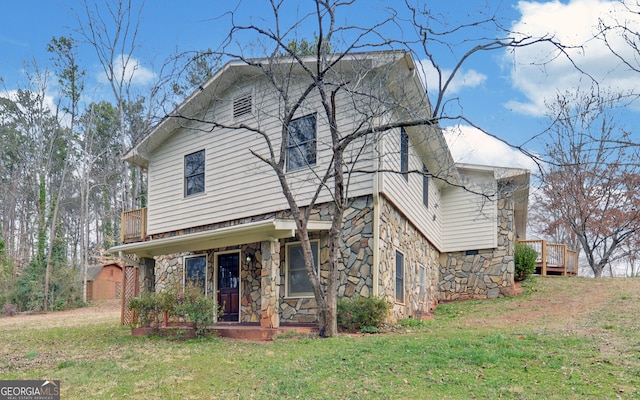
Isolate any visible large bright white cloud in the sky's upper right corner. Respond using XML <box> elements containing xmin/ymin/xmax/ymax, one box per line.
<box><xmin>505</xmin><ymin>0</ymin><xmax>640</xmax><ymax>116</ymax></box>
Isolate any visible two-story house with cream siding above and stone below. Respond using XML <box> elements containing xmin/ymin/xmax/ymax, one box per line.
<box><xmin>110</xmin><ymin>51</ymin><xmax>529</xmax><ymax>327</ymax></box>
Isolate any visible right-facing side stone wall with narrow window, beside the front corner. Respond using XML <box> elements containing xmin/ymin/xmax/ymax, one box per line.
<box><xmin>378</xmin><ymin>198</ymin><xmax>439</xmax><ymax>322</ymax></box>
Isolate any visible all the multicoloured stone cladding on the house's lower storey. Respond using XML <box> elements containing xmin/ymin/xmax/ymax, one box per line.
<box><xmin>144</xmin><ymin>192</ymin><xmax>515</xmax><ymax>323</ymax></box>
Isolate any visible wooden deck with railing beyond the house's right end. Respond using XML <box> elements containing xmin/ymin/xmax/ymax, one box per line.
<box><xmin>518</xmin><ymin>240</ymin><xmax>578</xmax><ymax>276</ymax></box>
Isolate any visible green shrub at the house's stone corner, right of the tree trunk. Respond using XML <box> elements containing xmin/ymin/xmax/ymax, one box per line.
<box><xmin>337</xmin><ymin>297</ymin><xmax>391</xmax><ymax>333</ymax></box>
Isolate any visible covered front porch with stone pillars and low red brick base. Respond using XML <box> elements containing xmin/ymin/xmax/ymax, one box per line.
<box><xmin>110</xmin><ymin>209</ymin><xmax>331</xmax><ymax>340</ymax></box>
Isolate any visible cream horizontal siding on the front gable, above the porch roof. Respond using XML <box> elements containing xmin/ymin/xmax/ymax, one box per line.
<box><xmin>147</xmin><ymin>74</ymin><xmax>372</xmax><ymax>234</ymax></box>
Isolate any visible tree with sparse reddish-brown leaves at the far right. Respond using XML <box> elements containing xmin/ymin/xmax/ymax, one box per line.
<box><xmin>541</xmin><ymin>91</ymin><xmax>640</xmax><ymax>277</ymax></box>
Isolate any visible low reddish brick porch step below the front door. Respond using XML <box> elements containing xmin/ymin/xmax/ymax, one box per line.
<box><xmin>213</xmin><ymin>322</ymin><xmax>317</xmax><ymax>341</ymax></box>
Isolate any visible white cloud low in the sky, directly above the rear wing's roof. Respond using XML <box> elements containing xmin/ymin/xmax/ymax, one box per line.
<box><xmin>444</xmin><ymin>125</ymin><xmax>538</xmax><ymax>172</ymax></box>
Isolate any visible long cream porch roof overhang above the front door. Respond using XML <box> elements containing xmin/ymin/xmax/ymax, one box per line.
<box><xmin>109</xmin><ymin>218</ymin><xmax>331</xmax><ymax>257</ymax></box>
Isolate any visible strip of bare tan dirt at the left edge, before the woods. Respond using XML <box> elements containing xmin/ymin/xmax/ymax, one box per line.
<box><xmin>0</xmin><ymin>300</ymin><xmax>121</xmax><ymax>329</ymax></box>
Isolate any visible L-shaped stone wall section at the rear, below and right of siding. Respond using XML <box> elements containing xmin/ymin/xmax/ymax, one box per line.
<box><xmin>439</xmin><ymin>190</ymin><xmax>515</xmax><ymax>300</ymax></box>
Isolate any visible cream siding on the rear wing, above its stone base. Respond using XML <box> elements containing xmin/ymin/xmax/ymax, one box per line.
<box><xmin>442</xmin><ymin>171</ymin><xmax>498</xmax><ymax>252</ymax></box>
